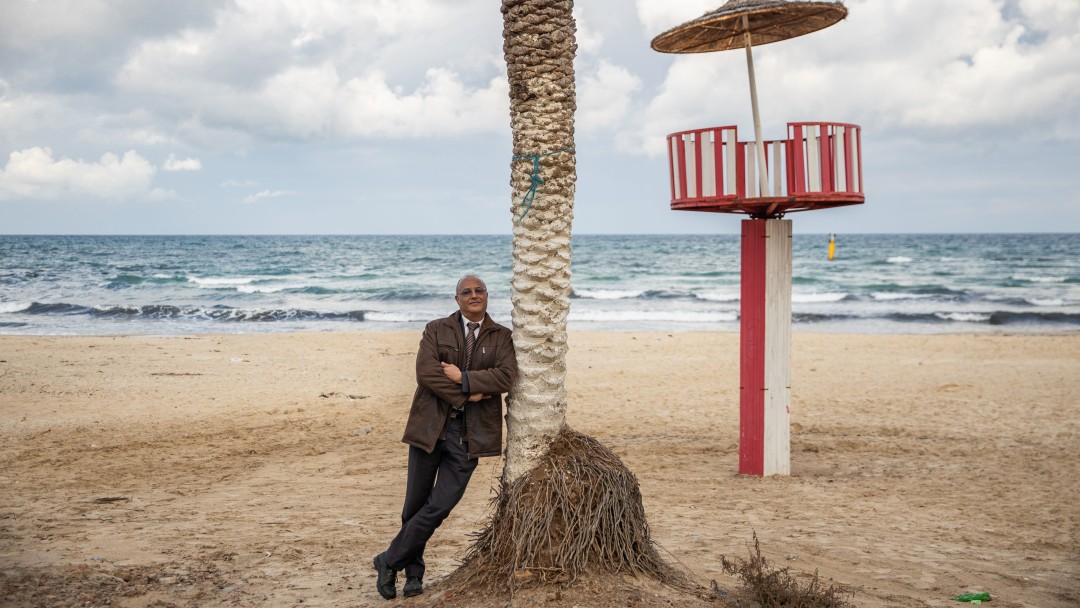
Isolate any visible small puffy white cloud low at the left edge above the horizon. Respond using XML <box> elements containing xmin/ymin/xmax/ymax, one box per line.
<box><xmin>0</xmin><ymin>147</ymin><xmax>173</xmax><ymax>201</ymax></box>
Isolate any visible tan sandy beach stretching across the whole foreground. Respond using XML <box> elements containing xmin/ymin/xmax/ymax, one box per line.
<box><xmin>0</xmin><ymin>332</ymin><xmax>1080</xmax><ymax>608</ymax></box>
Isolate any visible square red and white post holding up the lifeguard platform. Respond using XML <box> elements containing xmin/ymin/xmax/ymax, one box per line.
<box><xmin>739</xmin><ymin>219</ymin><xmax>792</xmax><ymax>476</ymax></box>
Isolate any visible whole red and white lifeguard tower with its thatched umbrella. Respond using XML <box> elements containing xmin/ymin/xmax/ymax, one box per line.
<box><xmin>652</xmin><ymin>0</ymin><xmax>864</xmax><ymax>476</ymax></box>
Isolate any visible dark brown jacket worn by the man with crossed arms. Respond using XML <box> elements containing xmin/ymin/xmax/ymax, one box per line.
<box><xmin>402</xmin><ymin>311</ymin><xmax>517</xmax><ymax>458</ymax></box>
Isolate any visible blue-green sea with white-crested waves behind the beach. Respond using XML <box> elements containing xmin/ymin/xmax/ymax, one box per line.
<box><xmin>0</xmin><ymin>233</ymin><xmax>1080</xmax><ymax>335</ymax></box>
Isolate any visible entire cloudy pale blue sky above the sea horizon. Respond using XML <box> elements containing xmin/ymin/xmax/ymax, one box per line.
<box><xmin>0</xmin><ymin>0</ymin><xmax>1080</xmax><ymax>234</ymax></box>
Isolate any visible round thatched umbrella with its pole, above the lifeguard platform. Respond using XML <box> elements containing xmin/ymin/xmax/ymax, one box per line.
<box><xmin>652</xmin><ymin>0</ymin><xmax>848</xmax><ymax>194</ymax></box>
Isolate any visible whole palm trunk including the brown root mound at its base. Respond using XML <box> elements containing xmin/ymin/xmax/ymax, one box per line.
<box><xmin>447</xmin><ymin>0</ymin><xmax>689</xmax><ymax>597</ymax></box>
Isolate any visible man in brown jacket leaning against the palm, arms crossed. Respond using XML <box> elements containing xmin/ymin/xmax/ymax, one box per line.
<box><xmin>374</xmin><ymin>275</ymin><xmax>517</xmax><ymax>599</ymax></box>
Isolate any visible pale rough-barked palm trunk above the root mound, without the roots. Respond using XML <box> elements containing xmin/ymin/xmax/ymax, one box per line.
<box><xmin>502</xmin><ymin>0</ymin><xmax>577</xmax><ymax>483</ymax></box>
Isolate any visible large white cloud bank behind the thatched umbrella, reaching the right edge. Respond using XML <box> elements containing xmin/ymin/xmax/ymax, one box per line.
<box><xmin>633</xmin><ymin>0</ymin><xmax>1080</xmax><ymax>154</ymax></box>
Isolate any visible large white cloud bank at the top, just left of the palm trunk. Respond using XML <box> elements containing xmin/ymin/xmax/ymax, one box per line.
<box><xmin>108</xmin><ymin>0</ymin><xmax>508</xmax><ymax>139</ymax></box>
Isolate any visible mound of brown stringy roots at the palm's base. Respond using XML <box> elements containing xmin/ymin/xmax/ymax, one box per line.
<box><xmin>446</xmin><ymin>428</ymin><xmax>693</xmax><ymax>594</ymax></box>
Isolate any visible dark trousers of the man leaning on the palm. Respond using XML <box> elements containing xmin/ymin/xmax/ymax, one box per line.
<box><xmin>383</xmin><ymin>416</ymin><xmax>477</xmax><ymax>579</ymax></box>
